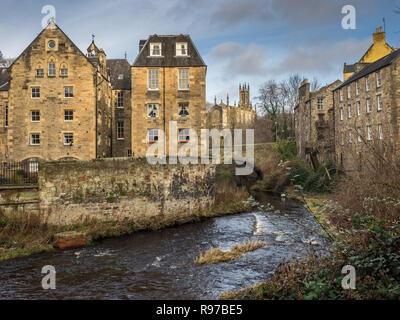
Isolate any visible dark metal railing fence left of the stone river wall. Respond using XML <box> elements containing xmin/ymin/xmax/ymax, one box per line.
<box><xmin>0</xmin><ymin>162</ymin><xmax>39</xmax><ymax>185</ymax></box>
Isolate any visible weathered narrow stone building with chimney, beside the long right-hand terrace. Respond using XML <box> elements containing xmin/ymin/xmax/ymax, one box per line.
<box><xmin>294</xmin><ymin>79</ymin><xmax>341</xmax><ymax>167</ymax></box>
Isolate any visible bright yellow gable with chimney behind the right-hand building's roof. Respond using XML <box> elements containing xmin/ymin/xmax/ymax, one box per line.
<box><xmin>343</xmin><ymin>27</ymin><xmax>395</xmax><ymax>80</ymax></box>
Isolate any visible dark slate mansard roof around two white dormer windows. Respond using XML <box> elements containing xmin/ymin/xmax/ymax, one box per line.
<box><xmin>133</xmin><ymin>34</ymin><xmax>206</xmax><ymax>67</ymax></box>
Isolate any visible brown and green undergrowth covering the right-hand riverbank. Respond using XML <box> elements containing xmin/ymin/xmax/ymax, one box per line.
<box><xmin>221</xmin><ymin>142</ymin><xmax>400</xmax><ymax>300</ymax></box>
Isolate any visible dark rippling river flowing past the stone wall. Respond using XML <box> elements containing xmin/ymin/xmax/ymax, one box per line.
<box><xmin>0</xmin><ymin>197</ymin><xmax>329</xmax><ymax>299</ymax></box>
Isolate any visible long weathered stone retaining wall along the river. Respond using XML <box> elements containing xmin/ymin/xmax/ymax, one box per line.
<box><xmin>39</xmin><ymin>158</ymin><xmax>215</xmax><ymax>225</ymax></box>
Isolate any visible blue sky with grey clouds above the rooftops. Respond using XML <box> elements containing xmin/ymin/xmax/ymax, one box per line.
<box><xmin>0</xmin><ymin>0</ymin><xmax>400</xmax><ymax>103</ymax></box>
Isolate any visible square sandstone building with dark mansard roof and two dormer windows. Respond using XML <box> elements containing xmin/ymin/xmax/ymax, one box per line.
<box><xmin>131</xmin><ymin>35</ymin><xmax>207</xmax><ymax>156</ymax></box>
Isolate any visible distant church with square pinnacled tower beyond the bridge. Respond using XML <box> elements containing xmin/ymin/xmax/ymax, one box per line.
<box><xmin>207</xmin><ymin>84</ymin><xmax>256</xmax><ymax>130</ymax></box>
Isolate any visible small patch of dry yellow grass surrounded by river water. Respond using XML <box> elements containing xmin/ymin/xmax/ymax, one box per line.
<box><xmin>194</xmin><ymin>240</ymin><xmax>267</xmax><ymax>264</ymax></box>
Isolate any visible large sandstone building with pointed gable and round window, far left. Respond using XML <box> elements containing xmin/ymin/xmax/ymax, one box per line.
<box><xmin>0</xmin><ymin>20</ymin><xmax>111</xmax><ymax>168</ymax></box>
